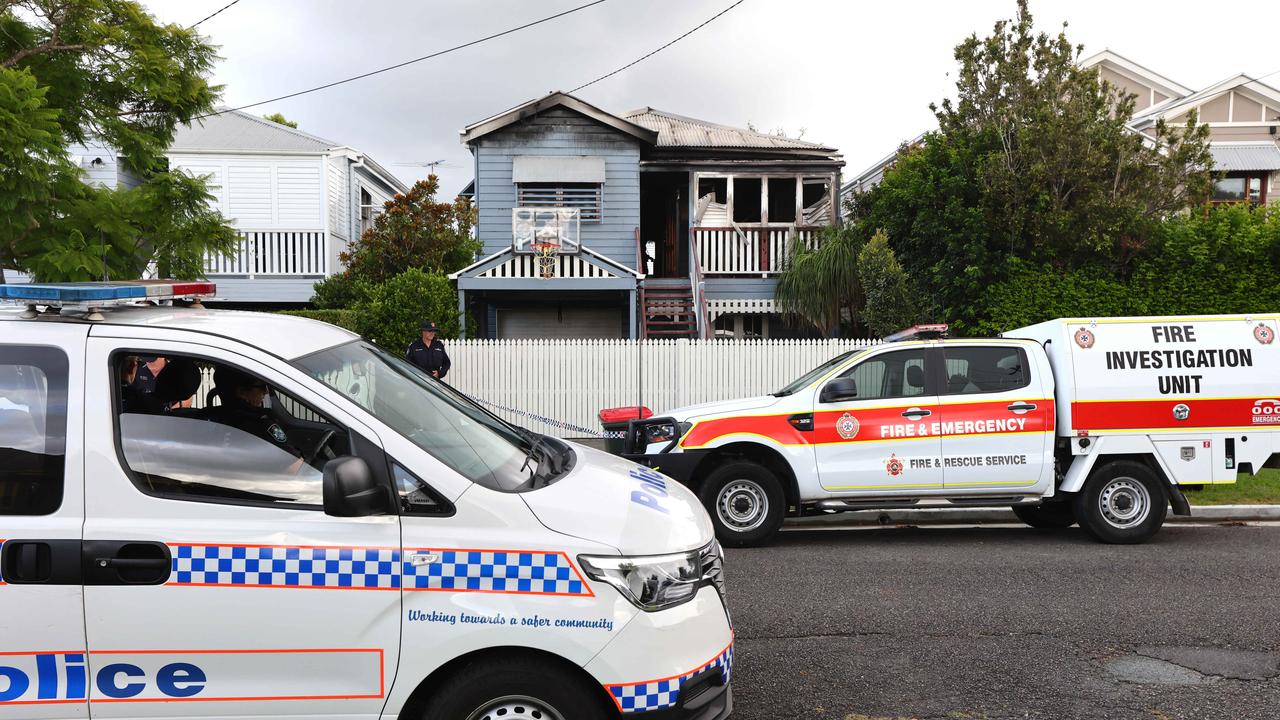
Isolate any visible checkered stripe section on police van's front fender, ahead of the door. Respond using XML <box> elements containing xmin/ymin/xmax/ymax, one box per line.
<box><xmin>404</xmin><ymin>550</ymin><xmax>593</xmax><ymax>596</ymax></box>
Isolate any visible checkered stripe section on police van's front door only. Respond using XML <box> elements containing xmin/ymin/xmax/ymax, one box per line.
<box><xmin>169</xmin><ymin>544</ymin><xmax>401</xmax><ymax>589</ymax></box>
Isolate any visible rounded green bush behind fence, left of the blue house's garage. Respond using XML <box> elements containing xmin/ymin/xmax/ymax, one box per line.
<box><xmin>352</xmin><ymin>268</ymin><xmax>461</xmax><ymax>352</ymax></box>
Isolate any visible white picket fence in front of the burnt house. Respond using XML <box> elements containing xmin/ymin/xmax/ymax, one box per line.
<box><xmin>445</xmin><ymin>340</ymin><xmax>878</xmax><ymax>437</ymax></box>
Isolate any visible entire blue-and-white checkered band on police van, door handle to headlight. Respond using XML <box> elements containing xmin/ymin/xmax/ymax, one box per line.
<box><xmin>169</xmin><ymin>543</ymin><xmax>594</xmax><ymax>597</ymax></box>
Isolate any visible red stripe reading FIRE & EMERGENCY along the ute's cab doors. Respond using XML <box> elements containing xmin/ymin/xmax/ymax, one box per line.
<box><xmin>680</xmin><ymin>398</ymin><xmax>1053</xmax><ymax>448</ymax></box>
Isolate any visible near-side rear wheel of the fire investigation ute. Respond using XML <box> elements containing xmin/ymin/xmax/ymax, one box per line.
<box><xmin>1074</xmin><ymin>460</ymin><xmax>1169</xmax><ymax>544</ymax></box>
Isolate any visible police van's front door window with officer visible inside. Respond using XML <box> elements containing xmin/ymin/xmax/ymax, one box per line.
<box><xmin>113</xmin><ymin>352</ymin><xmax>352</xmax><ymax>510</ymax></box>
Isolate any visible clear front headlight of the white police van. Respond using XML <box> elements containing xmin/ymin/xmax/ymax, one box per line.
<box><xmin>577</xmin><ymin>550</ymin><xmax>703</xmax><ymax>612</ymax></box>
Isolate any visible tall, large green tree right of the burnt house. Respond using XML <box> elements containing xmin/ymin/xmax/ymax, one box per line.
<box><xmin>851</xmin><ymin>0</ymin><xmax>1211</xmax><ymax>329</ymax></box>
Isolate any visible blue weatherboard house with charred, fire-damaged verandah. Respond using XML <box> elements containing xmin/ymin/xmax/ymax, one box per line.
<box><xmin>452</xmin><ymin>92</ymin><xmax>844</xmax><ymax>338</ymax></box>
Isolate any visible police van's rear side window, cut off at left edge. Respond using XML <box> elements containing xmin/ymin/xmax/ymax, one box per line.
<box><xmin>0</xmin><ymin>345</ymin><xmax>68</xmax><ymax>515</ymax></box>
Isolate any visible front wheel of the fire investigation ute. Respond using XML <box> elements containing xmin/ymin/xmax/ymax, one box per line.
<box><xmin>698</xmin><ymin>460</ymin><xmax>787</xmax><ymax>547</ymax></box>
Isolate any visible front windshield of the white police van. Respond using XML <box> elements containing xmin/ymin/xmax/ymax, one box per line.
<box><xmin>294</xmin><ymin>341</ymin><xmax>560</xmax><ymax>492</ymax></box>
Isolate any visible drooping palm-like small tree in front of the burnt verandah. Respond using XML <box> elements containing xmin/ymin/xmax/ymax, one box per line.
<box><xmin>774</xmin><ymin>227</ymin><xmax>864</xmax><ymax>336</ymax></box>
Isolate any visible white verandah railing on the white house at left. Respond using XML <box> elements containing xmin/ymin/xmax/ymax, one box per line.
<box><xmin>205</xmin><ymin>231</ymin><xmax>329</xmax><ymax>278</ymax></box>
